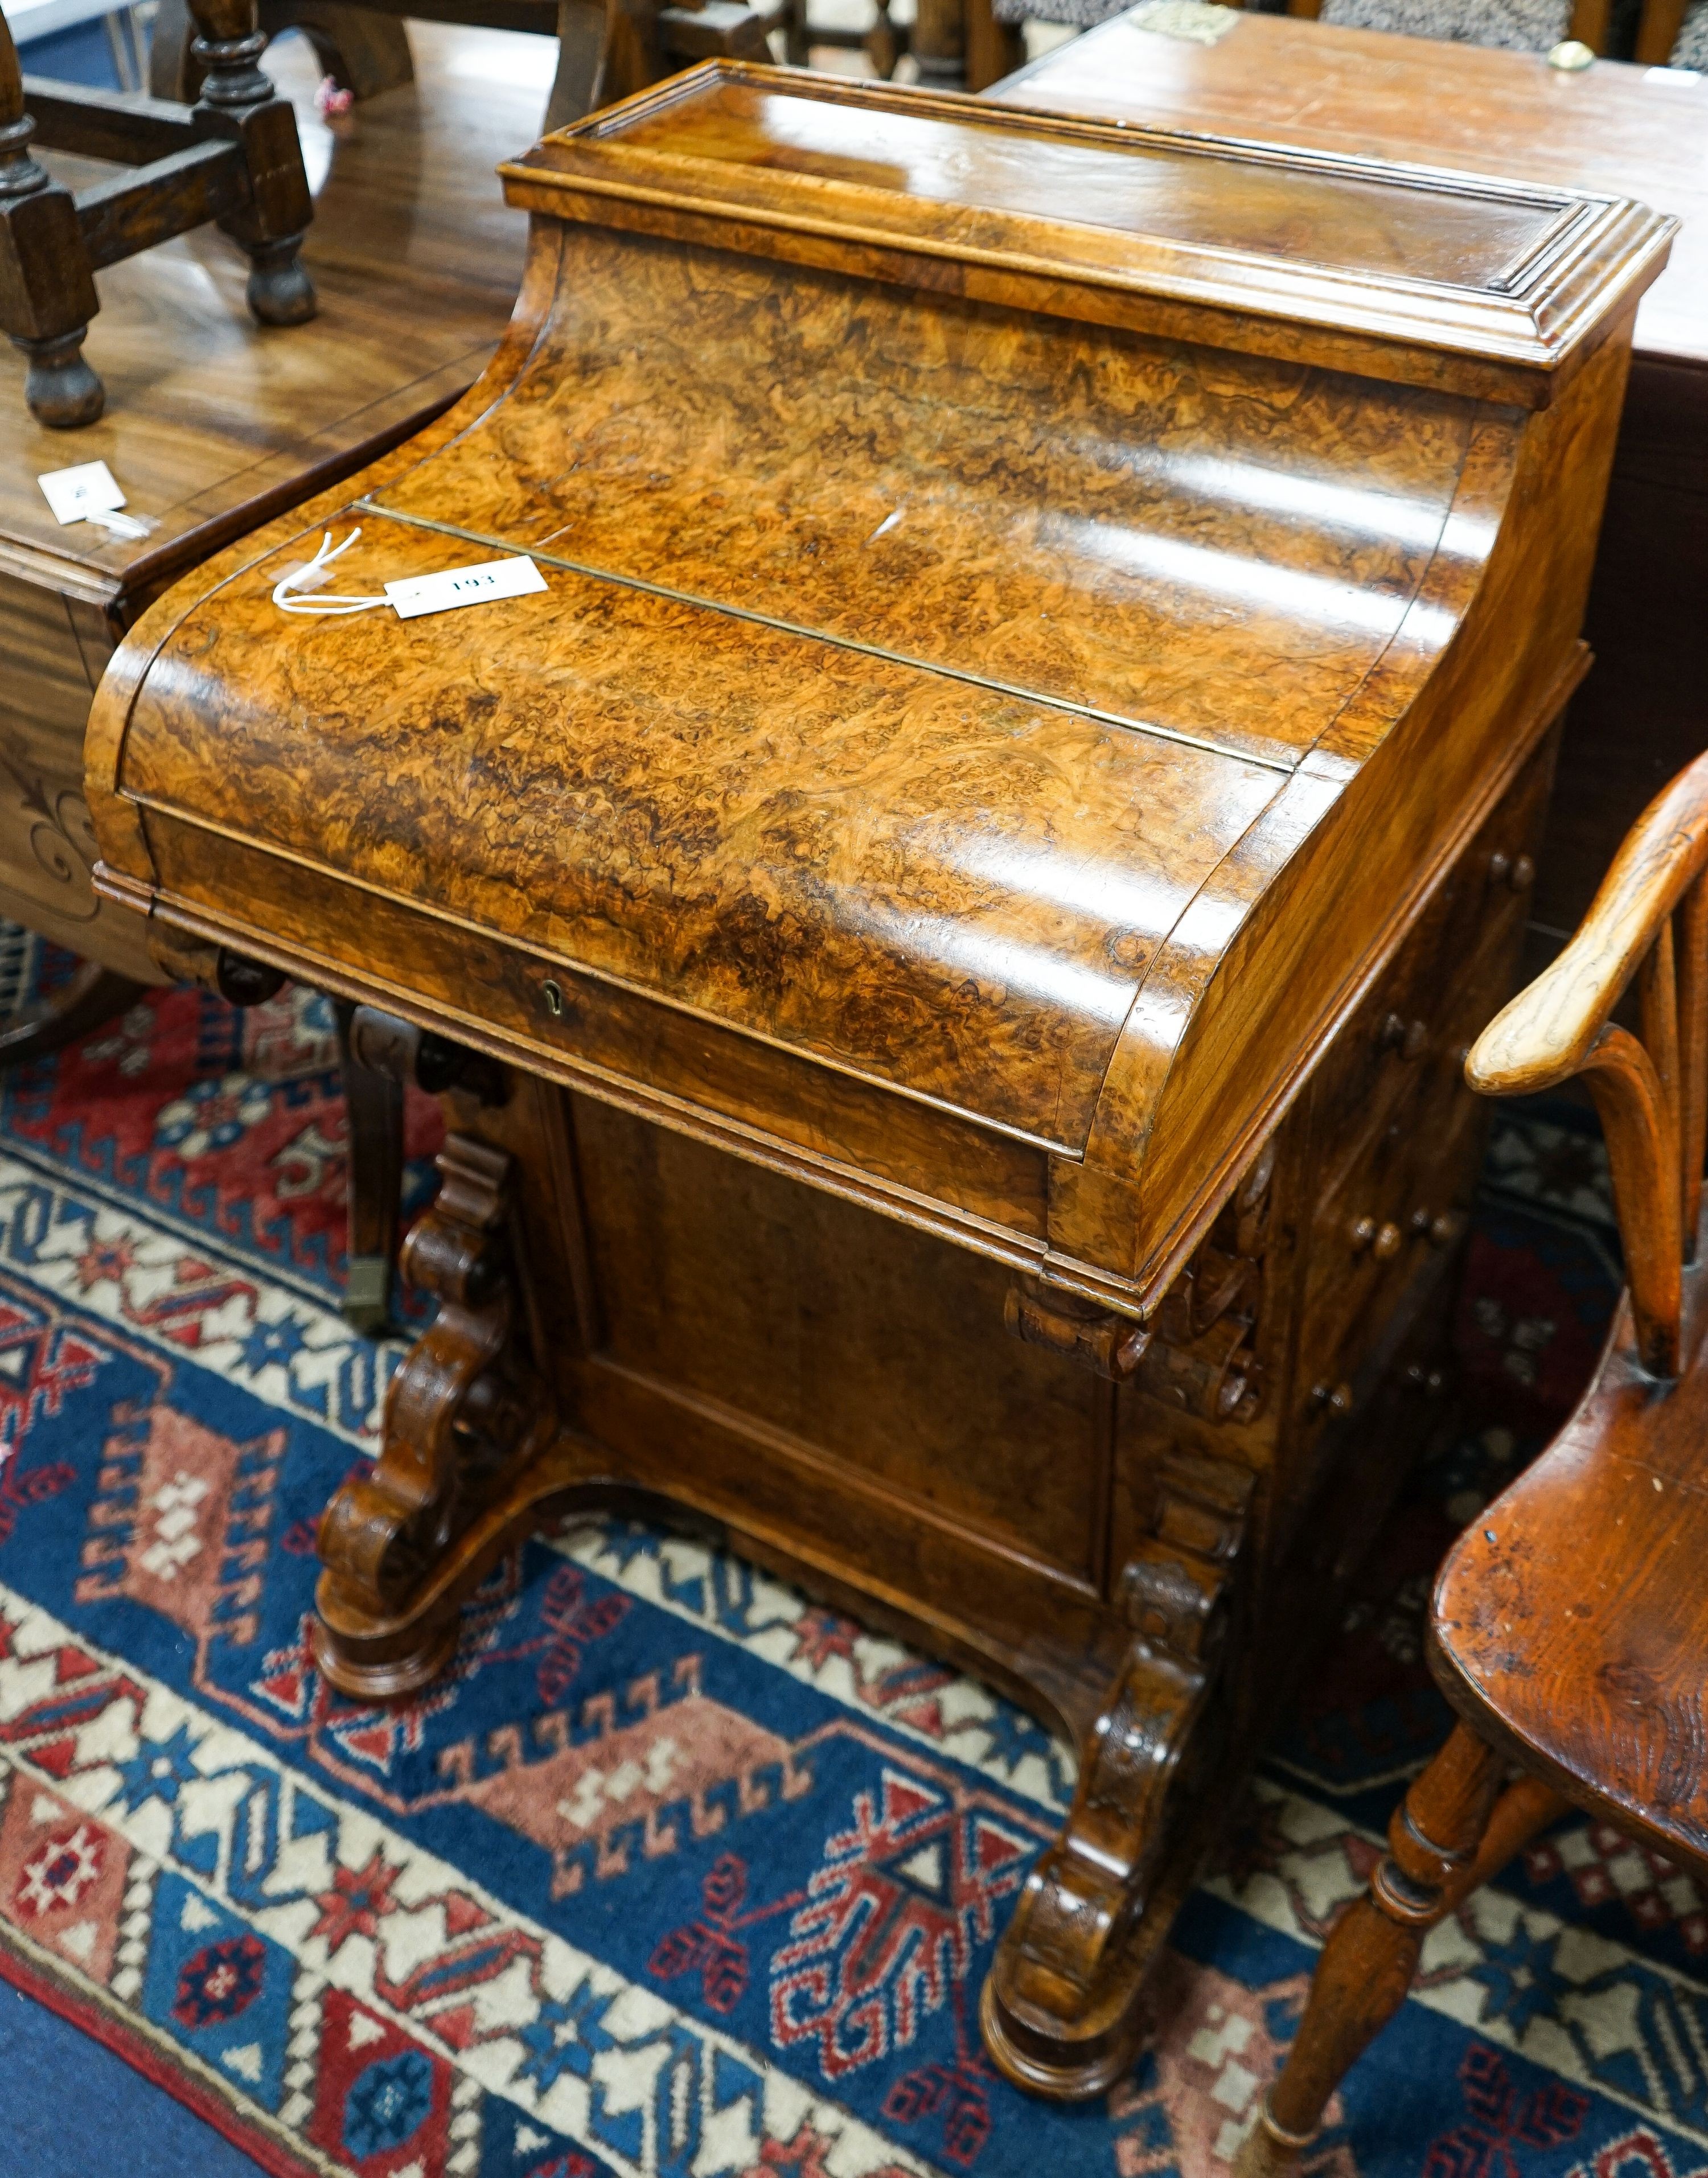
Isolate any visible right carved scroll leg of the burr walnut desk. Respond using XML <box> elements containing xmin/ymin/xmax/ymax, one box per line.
<box><xmin>980</xmin><ymin>1453</ymin><xmax>1253</xmax><ymax>2095</ymax></box>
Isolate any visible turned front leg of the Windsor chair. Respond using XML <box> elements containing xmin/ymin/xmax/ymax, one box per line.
<box><xmin>1233</xmin><ymin>1725</ymin><xmax>1566</xmax><ymax>2178</ymax></box>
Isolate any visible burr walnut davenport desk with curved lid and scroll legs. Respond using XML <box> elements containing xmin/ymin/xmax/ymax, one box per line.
<box><xmin>89</xmin><ymin>63</ymin><xmax>1669</xmax><ymax>2093</ymax></box>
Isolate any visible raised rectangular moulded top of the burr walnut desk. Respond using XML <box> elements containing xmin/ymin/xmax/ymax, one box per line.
<box><xmin>501</xmin><ymin>61</ymin><xmax>1677</xmax><ymax>407</ymax></box>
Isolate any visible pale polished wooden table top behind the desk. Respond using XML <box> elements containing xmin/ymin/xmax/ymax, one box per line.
<box><xmin>987</xmin><ymin>15</ymin><xmax>1708</xmax><ymax>366</ymax></box>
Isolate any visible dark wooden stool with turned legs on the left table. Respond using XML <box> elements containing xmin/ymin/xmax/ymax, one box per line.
<box><xmin>0</xmin><ymin>0</ymin><xmax>314</xmax><ymax>432</ymax></box>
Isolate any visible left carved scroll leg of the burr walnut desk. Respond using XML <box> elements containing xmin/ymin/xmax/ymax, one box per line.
<box><xmin>316</xmin><ymin>1124</ymin><xmax>558</xmax><ymax>1701</ymax></box>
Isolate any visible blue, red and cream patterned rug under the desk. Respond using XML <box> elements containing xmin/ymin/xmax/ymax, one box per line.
<box><xmin>0</xmin><ymin>939</ymin><xmax>1708</xmax><ymax>2178</ymax></box>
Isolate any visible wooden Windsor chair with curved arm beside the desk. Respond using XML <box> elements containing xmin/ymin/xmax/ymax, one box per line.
<box><xmin>1235</xmin><ymin>756</ymin><xmax>1708</xmax><ymax>2178</ymax></box>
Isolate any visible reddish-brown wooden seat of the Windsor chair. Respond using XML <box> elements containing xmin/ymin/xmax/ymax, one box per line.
<box><xmin>1434</xmin><ymin>1268</ymin><xmax>1708</xmax><ymax>1856</ymax></box>
